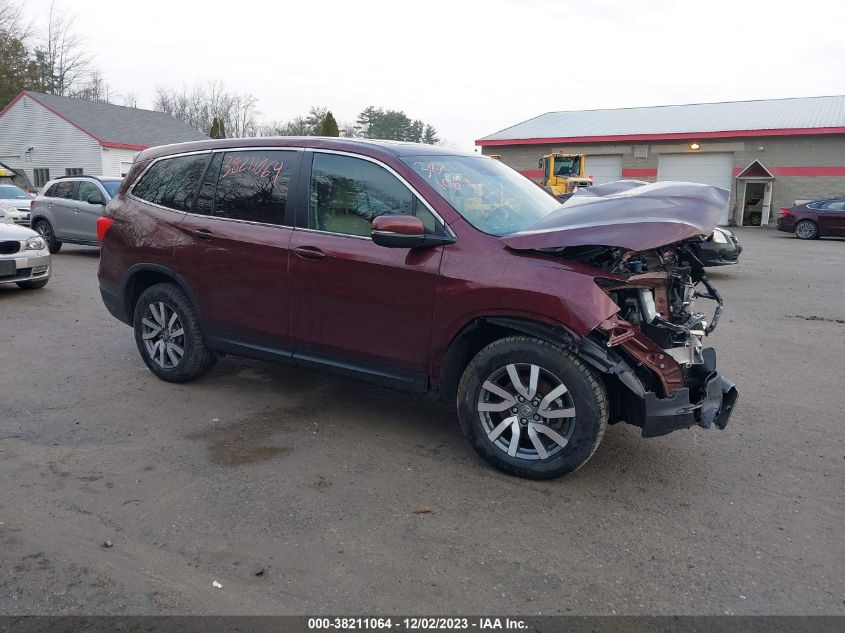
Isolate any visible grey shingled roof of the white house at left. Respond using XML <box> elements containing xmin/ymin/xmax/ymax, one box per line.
<box><xmin>7</xmin><ymin>90</ymin><xmax>208</xmax><ymax>149</ymax></box>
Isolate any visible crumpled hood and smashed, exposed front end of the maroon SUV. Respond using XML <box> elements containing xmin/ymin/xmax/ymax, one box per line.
<box><xmin>503</xmin><ymin>183</ymin><xmax>738</xmax><ymax>437</ymax></box>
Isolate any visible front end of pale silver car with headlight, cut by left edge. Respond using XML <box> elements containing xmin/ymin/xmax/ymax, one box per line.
<box><xmin>0</xmin><ymin>218</ymin><xmax>51</xmax><ymax>290</ymax></box>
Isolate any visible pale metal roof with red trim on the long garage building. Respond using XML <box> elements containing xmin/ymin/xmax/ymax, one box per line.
<box><xmin>476</xmin><ymin>95</ymin><xmax>845</xmax><ymax>145</ymax></box>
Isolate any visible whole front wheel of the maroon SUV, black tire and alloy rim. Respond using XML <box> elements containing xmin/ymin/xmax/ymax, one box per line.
<box><xmin>458</xmin><ymin>336</ymin><xmax>608</xmax><ymax>479</ymax></box>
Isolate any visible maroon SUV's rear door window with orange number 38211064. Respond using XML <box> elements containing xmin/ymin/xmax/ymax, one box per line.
<box><xmin>209</xmin><ymin>150</ymin><xmax>300</xmax><ymax>224</ymax></box>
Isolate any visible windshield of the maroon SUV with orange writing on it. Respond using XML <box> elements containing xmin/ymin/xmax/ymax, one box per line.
<box><xmin>402</xmin><ymin>156</ymin><xmax>560</xmax><ymax>235</ymax></box>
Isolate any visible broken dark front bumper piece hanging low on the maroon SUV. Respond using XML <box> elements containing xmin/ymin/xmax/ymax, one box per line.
<box><xmin>642</xmin><ymin>371</ymin><xmax>739</xmax><ymax>437</ymax></box>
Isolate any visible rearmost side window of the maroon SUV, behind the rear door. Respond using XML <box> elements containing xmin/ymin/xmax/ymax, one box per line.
<box><xmin>132</xmin><ymin>153</ymin><xmax>209</xmax><ymax>211</ymax></box>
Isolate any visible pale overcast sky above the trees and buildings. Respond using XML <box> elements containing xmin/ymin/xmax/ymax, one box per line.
<box><xmin>25</xmin><ymin>0</ymin><xmax>845</xmax><ymax>149</ymax></box>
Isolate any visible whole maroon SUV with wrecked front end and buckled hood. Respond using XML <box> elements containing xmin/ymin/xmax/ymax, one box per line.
<box><xmin>98</xmin><ymin>138</ymin><xmax>737</xmax><ymax>478</ymax></box>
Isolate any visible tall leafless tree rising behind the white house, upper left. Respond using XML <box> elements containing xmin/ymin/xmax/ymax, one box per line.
<box><xmin>35</xmin><ymin>4</ymin><xmax>91</xmax><ymax>95</ymax></box>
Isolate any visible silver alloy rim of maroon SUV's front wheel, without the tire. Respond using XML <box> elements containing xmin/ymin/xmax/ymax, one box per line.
<box><xmin>476</xmin><ymin>363</ymin><xmax>575</xmax><ymax>460</ymax></box>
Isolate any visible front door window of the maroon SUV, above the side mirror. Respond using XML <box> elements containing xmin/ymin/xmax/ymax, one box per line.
<box><xmin>309</xmin><ymin>153</ymin><xmax>440</xmax><ymax>237</ymax></box>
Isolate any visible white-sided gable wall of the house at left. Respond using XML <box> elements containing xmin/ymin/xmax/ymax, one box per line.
<box><xmin>0</xmin><ymin>95</ymin><xmax>103</xmax><ymax>182</ymax></box>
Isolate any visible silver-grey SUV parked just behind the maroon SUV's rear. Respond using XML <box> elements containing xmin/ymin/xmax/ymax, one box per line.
<box><xmin>32</xmin><ymin>176</ymin><xmax>123</xmax><ymax>253</ymax></box>
